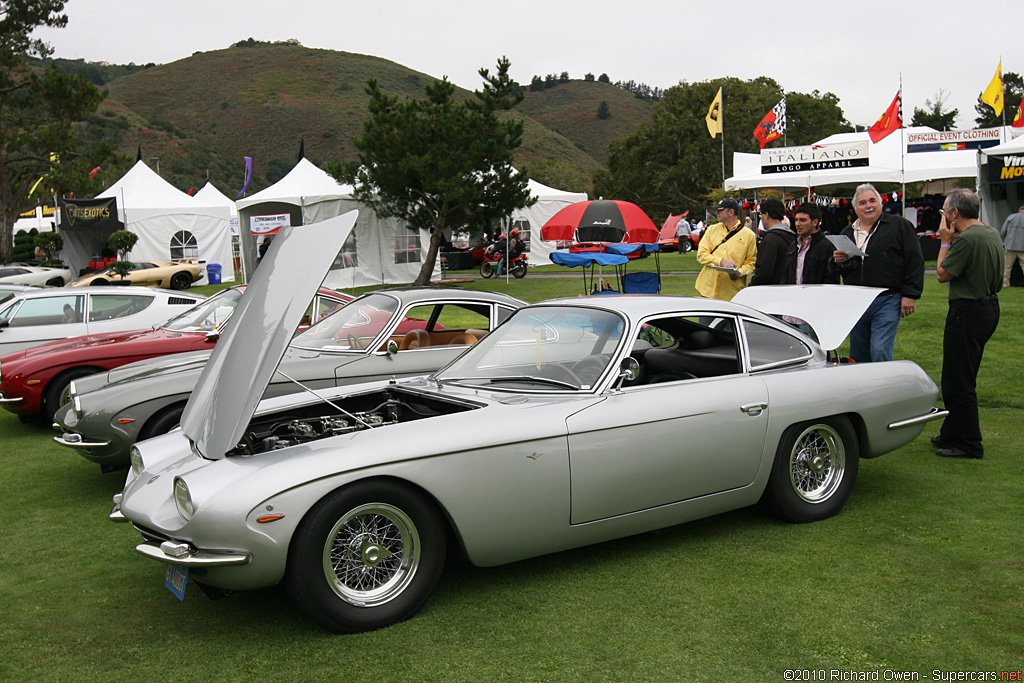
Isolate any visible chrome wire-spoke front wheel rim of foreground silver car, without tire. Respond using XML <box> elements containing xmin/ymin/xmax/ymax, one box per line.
<box><xmin>324</xmin><ymin>503</ymin><xmax>421</xmax><ymax>606</ymax></box>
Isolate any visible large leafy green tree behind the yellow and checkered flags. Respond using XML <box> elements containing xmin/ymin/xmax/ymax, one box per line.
<box><xmin>594</xmin><ymin>77</ymin><xmax>850</xmax><ymax>216</ymax></box>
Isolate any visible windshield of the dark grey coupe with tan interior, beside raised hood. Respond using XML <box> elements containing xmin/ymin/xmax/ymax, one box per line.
<box><xmin>292</xmin><ymin>294</ymin><xmax>398</xmax><ymax>351</ymax></box>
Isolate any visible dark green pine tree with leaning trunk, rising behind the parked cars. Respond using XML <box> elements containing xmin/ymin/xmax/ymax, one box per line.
<box><xmin>327</xmin><ymin>57</ymin><xmax>532</xmax><ymax>285</ymax></box>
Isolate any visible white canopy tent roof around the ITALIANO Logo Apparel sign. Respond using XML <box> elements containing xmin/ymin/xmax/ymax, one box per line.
<box><xmin>725</xmin><ymin>127</ymin><xmax>1003</xmax><ymax>189</ymax></box>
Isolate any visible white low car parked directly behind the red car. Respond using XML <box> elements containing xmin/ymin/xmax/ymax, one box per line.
<box><xmin>0</xmin><ymin>287</ymin><xmax>206</xmax><ymax>355</ymax></box>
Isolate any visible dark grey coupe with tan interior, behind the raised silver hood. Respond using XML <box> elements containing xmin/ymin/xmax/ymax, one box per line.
<box><xmin>53</xmin><ymin>287</ymin><xmax>525</xmax><ymax>471</ymax></box>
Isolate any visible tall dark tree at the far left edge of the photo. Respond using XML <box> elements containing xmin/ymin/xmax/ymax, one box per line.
<box><xmin>0</xmin><ymin>0</ymin><xmax>111</xmax><ymax>263</ymax></box>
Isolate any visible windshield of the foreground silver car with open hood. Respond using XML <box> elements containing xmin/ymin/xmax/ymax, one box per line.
<box><xmin>438</xmin><ymin>306</ymin><xmax>625</xmax><ymax>391</ymax></box>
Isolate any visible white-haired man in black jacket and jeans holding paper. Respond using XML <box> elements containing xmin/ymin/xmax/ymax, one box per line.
<box><xmin>828</xmin><ymin>183</ymin><xmax>925</xmax><ymax>362</ymax></box>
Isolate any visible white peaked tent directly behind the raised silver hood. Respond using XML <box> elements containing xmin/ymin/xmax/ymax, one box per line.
<box><xmin>236</xmin><ymin>158</ymin><xmax>440</xmax><ymax>289</ymax></box>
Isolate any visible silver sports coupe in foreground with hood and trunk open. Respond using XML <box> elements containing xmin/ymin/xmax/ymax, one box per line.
<box><xmin>111</xmin><ymin>215</ymin><xmax>942</xmax><ymax>632</ymax></box>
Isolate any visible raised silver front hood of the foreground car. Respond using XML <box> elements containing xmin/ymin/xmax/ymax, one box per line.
<box><xmin>181</xmin><ymin>211</ymin><xmax>356</xmax><ymax>459</ymax></box>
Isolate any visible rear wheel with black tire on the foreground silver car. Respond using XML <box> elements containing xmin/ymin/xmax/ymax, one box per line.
<box><xmin>761</xmin><ymin>417</ymin><xmax>860</xmax><ymax>523</ymax></box>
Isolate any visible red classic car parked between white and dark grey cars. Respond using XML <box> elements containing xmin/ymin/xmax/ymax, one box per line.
<box><xmin>0</xmin><ymin>286</ymin><xmax>352</xmax><ymax>422</ymax></box>
